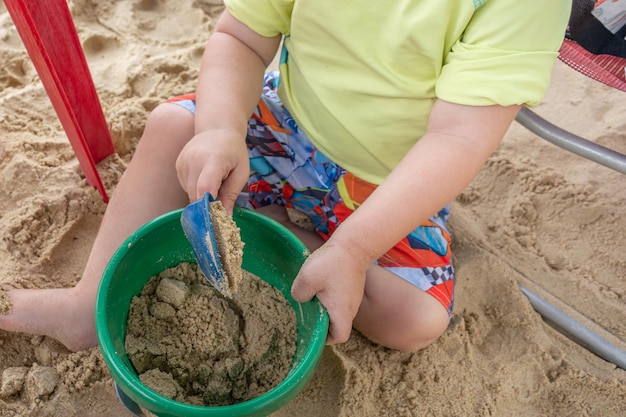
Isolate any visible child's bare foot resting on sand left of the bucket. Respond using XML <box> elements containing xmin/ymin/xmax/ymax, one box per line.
<box><xmin>0</xmin><ymin>288</ymin><xmax>98</xmax><ymax>351</ymax></box>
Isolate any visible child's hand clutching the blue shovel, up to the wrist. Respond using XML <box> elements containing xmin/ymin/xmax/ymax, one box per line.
<box><xmin>176</xmin><ymin>129</ymin><xmax>250</xmax><ymax>213</ymax></box>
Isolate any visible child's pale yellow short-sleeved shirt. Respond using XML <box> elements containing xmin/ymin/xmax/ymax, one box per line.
<box><xmin>225</xmin><ymin>0</ymin><xmax>571</xmax><ymax>184</ymax></box>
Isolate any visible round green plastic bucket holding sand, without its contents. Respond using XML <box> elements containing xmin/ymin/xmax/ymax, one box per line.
<box><xmin>96</xmin><ymin>208</ymin><xmax>328</xmax><ymax>417</ymax></box>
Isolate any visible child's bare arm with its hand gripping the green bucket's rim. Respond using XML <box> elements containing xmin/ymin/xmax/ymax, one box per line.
<box><xmin>292</xmin><ymin>100</ymin><xmax>519</xmax><ymax>343</ymax></box>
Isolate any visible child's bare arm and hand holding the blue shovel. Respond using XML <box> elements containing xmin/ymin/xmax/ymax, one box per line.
<box><xmin>176</xmin><ymin>11</ymin><xmax>281</xmax><ymax>211</ymax></box>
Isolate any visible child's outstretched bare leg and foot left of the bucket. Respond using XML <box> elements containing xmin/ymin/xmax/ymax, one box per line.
<box><xmin>0</xmin><ymin>104</ymin><xmax>193</xmax><ymax>351</ymax></box>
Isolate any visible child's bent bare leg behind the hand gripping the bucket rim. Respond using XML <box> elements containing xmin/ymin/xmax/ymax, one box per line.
<box><xmin>257</xmin><ymin>204</ymin><xmax>449</xmax><ymax>351</ymax></box>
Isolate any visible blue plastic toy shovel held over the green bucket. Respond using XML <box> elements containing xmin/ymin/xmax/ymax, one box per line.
<box><xmin>180</xmin><ymin>193</ymin><xmax>231</xmax><ymax>297</ymax></box>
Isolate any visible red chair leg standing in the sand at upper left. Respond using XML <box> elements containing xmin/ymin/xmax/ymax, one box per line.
<box><xmin>4</xmin><ymin>0</ymin><xmax>115</xmax><ymax>202</ymax></box>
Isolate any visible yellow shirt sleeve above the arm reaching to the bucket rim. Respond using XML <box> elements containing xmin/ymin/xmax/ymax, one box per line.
<box><xmin>436</xmin><ymin>0</ymin><xmax>571</xmax><ymax>106</ymax></box>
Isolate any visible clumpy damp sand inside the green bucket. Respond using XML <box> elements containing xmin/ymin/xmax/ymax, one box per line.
<box><xmin>126</xmin><ymin>263</ymin><xmax>296</xmax><ymax>406</ymax></box>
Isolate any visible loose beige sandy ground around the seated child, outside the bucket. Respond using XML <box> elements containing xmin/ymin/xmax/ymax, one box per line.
<box><xmin>0</xmin><ymin>0</ymin><xmax>626</xmax><ymax>417</ymax></box>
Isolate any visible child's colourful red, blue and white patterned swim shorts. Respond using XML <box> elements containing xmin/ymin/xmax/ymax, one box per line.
<box><xmin>168</xmin><ymin>72</ymin><xmax>454</xmax><ymax>313</ymax></box>
